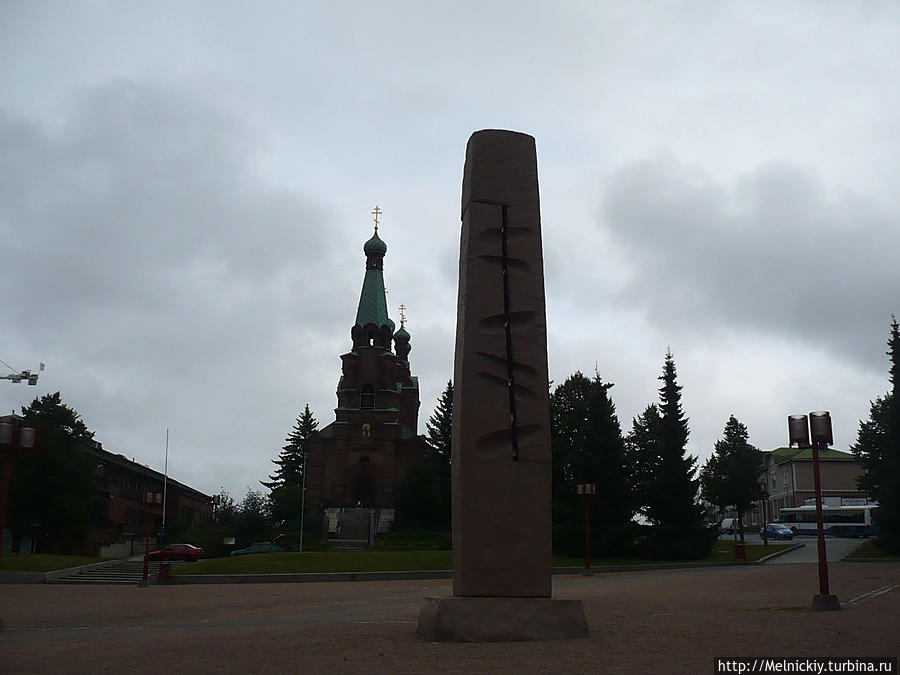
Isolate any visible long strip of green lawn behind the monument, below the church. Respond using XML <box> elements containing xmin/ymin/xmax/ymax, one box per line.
<box><xmin>172</xmin><ymin>540</ymin><xmax>790</xmax><ymax>574</ymax></box>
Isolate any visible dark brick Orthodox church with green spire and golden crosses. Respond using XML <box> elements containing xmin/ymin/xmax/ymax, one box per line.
<box><xmin>306</xmin><ymin>214</ymin><xmax>426</xmax><ymax>509</ymax></box>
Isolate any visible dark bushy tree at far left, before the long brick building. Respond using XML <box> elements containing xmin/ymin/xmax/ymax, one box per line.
<box><xmin>9</xmin><ymin>392</ymin><xmax>94</xmax><ymax>553</ymax></box>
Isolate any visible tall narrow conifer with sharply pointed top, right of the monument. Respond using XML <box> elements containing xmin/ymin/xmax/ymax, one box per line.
<box><xmin>642</xmin><ymin>350</ymin><xmax>713</xmax><ymax>559</ymax></box>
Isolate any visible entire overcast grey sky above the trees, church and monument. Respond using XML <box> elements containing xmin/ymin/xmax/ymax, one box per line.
<box><xmin>0</xmin><ymin>0</ymin><xmax>900</xmax><ymax>498</ymax></box>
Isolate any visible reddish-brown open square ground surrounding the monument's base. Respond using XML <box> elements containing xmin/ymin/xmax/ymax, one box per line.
<box><xmin>0</xmin><ymin>563</ymin><xmax>900</xmax><ymax>673</ymax></box>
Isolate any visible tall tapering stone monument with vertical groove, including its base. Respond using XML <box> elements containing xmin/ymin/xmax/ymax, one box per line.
<box><xmin>418</xmin><ymin>130</ymin><xmax>588</xmax><ymax>642</ymax></box>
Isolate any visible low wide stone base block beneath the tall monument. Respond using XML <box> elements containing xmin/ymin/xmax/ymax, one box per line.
<box><xmin>416</xmin><ymin>596</ymin><xmax>590</xmax><ymax>642</ymax></box>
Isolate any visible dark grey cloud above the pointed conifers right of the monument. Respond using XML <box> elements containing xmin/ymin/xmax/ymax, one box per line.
<box><xmin>601</xmin><ymin>158</ymin><xmax>900</xmax><ymax>369</ymax></box>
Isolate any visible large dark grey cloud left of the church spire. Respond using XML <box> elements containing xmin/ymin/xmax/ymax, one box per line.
<box><xmin>0</xmin><ymin>81</ymin><xmax>358</xmax><ymax>490</ymax></box>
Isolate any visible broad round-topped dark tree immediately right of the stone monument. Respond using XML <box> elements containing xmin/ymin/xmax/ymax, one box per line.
<box><xmin>550</xmin><ymin>372</ymin><xmax>631</xmax><ymax>555</ymax></box>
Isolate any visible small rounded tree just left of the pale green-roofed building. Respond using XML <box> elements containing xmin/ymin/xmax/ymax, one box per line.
<box><xmin>700</xmin><ymin>415</ymin><xmax>764</xmax><ymax>541</ymax></box>
